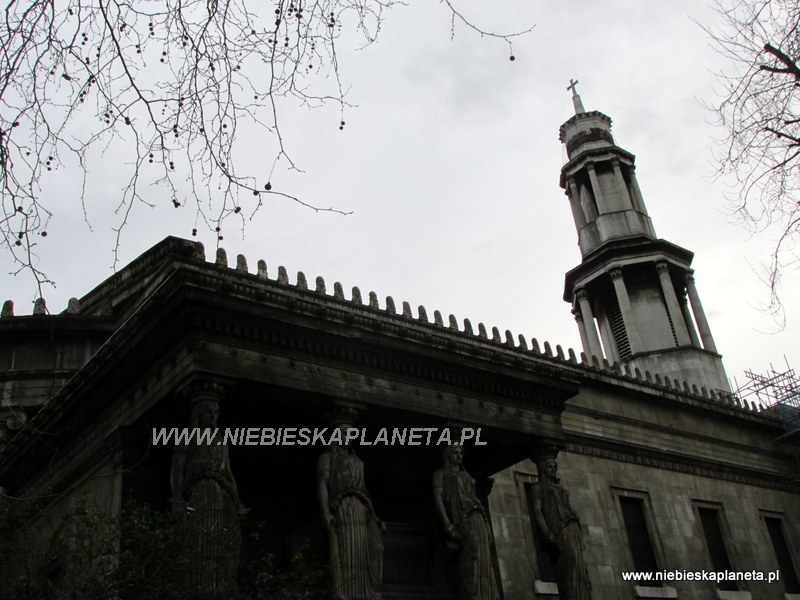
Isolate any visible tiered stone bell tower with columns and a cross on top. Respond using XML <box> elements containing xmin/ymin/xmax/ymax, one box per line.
<box><xmin>559</xmin><ymin>80</ymin><xmax>730</xmax><ymax>391</ymax></box>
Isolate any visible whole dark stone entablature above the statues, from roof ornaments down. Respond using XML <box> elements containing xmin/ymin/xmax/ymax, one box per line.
<box><xmin>0</xmin><ymin>239</ymin><xmax>780</xmax><ymax>502</ymax></box>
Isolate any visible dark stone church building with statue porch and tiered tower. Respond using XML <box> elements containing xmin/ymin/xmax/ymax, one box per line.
<box><xmin>0</xmin><ymin>90</ymin><xmax>800</xmax><ymax>600</ymax></box>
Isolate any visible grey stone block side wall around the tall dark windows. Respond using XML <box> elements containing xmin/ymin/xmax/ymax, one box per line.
<box><xmin>492</xmin><ymin>384</ymin><xmax>800</xmax><ymax>600</ymax></box>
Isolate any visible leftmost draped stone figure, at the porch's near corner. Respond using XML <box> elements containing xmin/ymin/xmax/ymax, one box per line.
<box><xmin>171</xmin><ymin>384</ymin><xmax>241</xmax><ymax>598</ymax></box>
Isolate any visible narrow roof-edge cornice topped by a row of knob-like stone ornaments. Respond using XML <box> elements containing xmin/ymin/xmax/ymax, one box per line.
<box><xmin>0</xmin><ymin>238</ymin><xmax>773</xmax><ymax>434</ymax></box>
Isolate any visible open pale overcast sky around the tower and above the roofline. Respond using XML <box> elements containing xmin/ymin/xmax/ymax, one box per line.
<box><xmin>0</xmin><ymin>0</ymin><xmax>800</xmax><ymax>398</ymax></box>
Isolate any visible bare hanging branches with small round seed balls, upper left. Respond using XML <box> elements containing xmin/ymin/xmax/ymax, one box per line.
<box><xmin>0</xmin><ymin>0</ymin><xmax>524</xmax><ymax>294</ymax></box>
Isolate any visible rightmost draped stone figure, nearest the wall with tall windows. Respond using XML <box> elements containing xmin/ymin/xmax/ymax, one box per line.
<box><xmin>533</xmin><ymin>457</ymin><xmax>592</xmax><ymax>600</ymax></box>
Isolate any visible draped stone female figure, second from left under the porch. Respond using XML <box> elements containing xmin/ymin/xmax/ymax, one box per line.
<box><xmin>317</xmin><ymin>424</ymin><xmax>385</xmax><ymax>600</ymax></box>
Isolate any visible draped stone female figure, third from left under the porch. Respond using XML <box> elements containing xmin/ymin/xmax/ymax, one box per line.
<box><xmin>433</xmin><ymin>445</ymin><xmax>500</xmax><ymax>600</ymax></box>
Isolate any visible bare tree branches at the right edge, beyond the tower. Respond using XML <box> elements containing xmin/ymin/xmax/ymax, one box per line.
<box><xmin>705</xmin><ymin>0</ymin><xmax>800</xmax><ymax>323</ymax></box>
